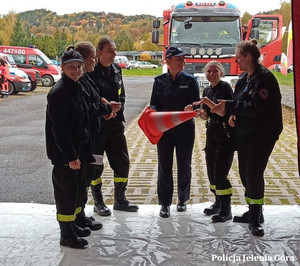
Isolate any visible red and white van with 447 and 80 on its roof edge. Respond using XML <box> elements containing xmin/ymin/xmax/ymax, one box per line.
<box><xmin>0</xmin><ymin>45</ymin><xmax>61</xmax><ymax>87</ymax></box>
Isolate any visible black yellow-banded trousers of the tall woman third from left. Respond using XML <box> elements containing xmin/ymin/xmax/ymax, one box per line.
<box><xmin>90</xmin><ymin>119</ymin><xmax>130</xmax><ymax>185</ymax></box>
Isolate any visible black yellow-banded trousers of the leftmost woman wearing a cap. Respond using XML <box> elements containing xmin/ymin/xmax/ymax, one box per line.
<box><xmin>52</xmin><ymin>163</ymin><xmax>86</xmax><ymax>222</ymax></box>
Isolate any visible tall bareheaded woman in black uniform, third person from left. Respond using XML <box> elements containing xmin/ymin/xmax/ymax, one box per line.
<box><xmin>90</xmin><ymin>36</ymin><xmax>138</xmax><ymax>216</ymax></box>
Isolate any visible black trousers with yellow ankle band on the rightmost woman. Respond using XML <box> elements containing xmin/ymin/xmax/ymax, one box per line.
<box><xmin>237</xmin><ymin>137</ymin><xmax>276</xmax><ymax>205</ymax></box>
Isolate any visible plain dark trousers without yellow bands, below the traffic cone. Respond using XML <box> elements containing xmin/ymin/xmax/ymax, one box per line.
<box><xmin>157</xmin><ymin>120</ymin><xmax>195</xmax><ymax>206</ymax></box>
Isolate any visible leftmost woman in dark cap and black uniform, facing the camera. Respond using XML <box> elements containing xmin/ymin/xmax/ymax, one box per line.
<box><xmin>46</xmin><ymin>51</ymin><xmax>90</xmax><ymax>248</ymax></box>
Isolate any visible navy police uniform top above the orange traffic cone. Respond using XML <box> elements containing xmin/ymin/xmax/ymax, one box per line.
<box><xmin>150</xmin><ymin>71</ymin><xmax>200</xmax><ymax>111</ymax></box>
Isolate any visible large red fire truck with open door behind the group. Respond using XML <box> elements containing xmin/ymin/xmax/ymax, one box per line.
<box><xmin>152</xmin><ymin>1</ymin><xmax>282</xmax><ymax>88</ymax></box>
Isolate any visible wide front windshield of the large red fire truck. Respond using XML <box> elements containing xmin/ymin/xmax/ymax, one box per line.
<box><xmin>170</xmin><ymin>16</ymin><xmax>241</xmax><ymax>47</ymax></box>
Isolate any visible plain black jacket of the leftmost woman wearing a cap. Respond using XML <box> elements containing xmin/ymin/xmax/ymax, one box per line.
<box><xmin>46</xmin><ymin>74</ymin><xmax>89</xmax><ymax>164</ymax></box>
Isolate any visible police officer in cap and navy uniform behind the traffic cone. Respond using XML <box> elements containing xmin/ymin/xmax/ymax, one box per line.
<box><xmin>150</xmin><ymin>47</ymin><xmax>199</xmax><ymax>218</ymax></box>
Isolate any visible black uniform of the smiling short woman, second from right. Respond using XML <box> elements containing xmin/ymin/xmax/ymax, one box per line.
<box><xmin>203</xmin><ymin>80</ymin><xmax>235</xmax><ymax>196</ymax></box>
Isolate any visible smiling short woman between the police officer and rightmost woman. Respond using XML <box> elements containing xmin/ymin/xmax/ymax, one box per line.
<box><xmin>194</xmin><ymin>61</ymin><xmax>235</xmax><ymax>222</ymax></box>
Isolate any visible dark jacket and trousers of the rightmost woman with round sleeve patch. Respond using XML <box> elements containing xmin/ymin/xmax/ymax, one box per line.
<box><xmin>226</xmin><ymin>66</ymin><xmax>282</xmax><ymax>205</ymax></box>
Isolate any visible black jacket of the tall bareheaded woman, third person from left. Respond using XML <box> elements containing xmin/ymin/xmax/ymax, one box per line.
<box><xmin>89</xmin><ymin>62</ymin><xmax>125</xmax><ymax>122</ymax></box>
